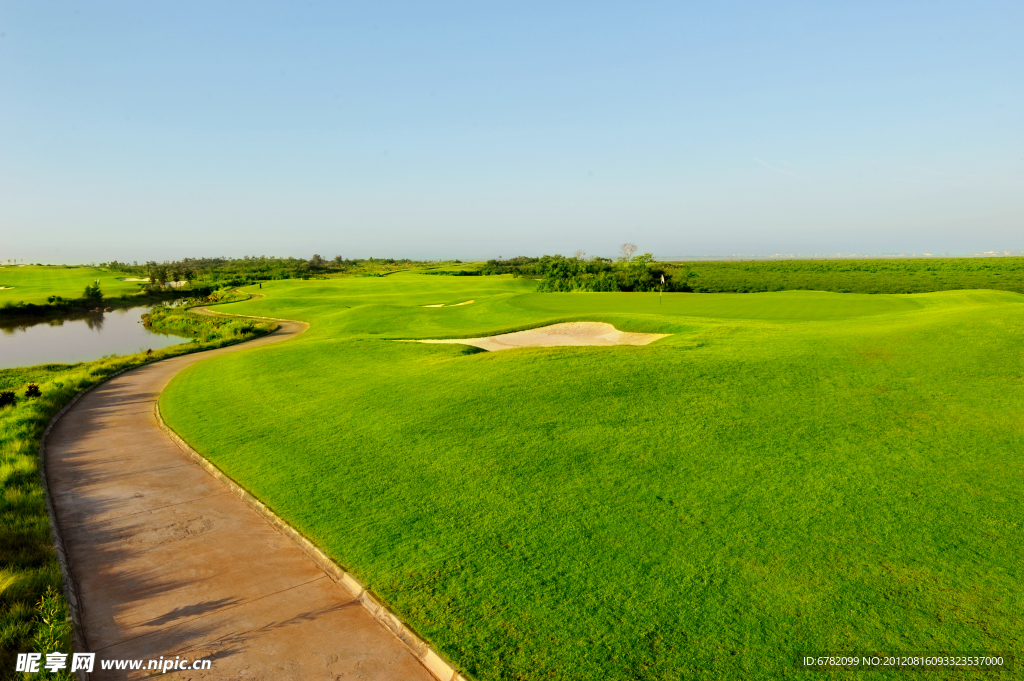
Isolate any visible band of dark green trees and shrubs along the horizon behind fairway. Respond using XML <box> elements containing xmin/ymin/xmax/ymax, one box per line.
<box><xmin>96</xmin><ymin>250</ymin><xmax>1024</xmax><ymax>293</ymax></box>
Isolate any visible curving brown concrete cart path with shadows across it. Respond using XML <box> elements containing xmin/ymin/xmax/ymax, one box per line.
<box><xmin>46</xmin><ymin>322</ymin><xmax>433</xmax><ymax>681</ymax></box>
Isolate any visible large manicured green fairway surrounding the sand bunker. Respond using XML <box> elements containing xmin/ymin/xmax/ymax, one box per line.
<box><xmin>161</xmin><ymin>273</ymin><xmax>1024</xmax><ymax>679</ymax></box>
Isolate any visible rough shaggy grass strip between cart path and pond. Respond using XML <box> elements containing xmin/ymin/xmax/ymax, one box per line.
<box><xmin>0</xmin><ymin>308</ymin><xmax>273</xmax><ymax>679</ymax></box>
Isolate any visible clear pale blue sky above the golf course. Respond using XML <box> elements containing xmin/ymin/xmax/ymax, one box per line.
<box><xmin>0</xmin><ymin>0</ymin><xmax>1024</xmax><ymax>262</ymax></box>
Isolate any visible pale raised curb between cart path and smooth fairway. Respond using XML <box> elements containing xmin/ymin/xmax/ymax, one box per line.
<box><xmin>154</xmin><ymin>403</ymin><xmax>469</xmax><ymax>681</ymax></box>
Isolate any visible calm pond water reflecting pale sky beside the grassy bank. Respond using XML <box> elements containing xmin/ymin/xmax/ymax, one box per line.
<box><xmin>0</xmin><ymin>307</ymin><xmax>188</xmax><ymax>369</ymax></box>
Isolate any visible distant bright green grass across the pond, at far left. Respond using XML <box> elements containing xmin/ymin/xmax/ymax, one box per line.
<box><xmin>0</xmin><ymin>265</ymin><xmax>142</xmax><ymax>305</ymax></box>
